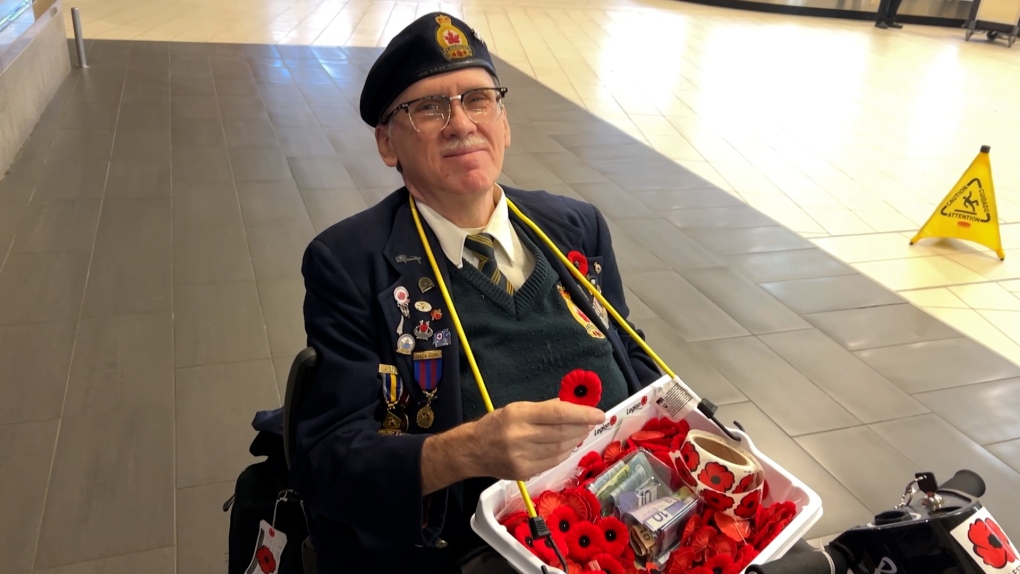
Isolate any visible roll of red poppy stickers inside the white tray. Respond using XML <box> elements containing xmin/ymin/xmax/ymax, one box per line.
<box><xmin>671</xmin><ymin>430</ymin><xmax>765</xmax><ymax>520</ymax></box>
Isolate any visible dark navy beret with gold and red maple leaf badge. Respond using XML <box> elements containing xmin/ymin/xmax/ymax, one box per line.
<box><xmin>360</xmin><ymin>12</ymin><xmax>497</xmax><ymax>127</ymax></box>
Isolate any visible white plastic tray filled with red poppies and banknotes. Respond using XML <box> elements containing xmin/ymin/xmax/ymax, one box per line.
<box><xmin>471</xmin><ymin>373</ymin><xmax>822</xmax><ymax>574</ymax></box>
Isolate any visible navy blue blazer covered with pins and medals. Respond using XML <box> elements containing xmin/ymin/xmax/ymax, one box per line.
<box><xmin>292</xmin><ymin>188</ymin><xmax>660</xmax><ymax>574</ymax></box>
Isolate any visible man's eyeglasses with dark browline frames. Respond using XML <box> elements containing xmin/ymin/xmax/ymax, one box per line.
<box><xmin>379</xmin><ymin>88</ymin><xmax>507</xmax><ymax>134</ymax></box>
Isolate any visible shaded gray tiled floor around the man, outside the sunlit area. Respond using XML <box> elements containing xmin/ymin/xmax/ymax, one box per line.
<box><xmin>0</xmin><ymin>41</ymin><xmax>1020</xmax><ymax>573</ymax></box>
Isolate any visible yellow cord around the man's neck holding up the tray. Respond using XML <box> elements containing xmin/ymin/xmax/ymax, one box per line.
<box><xmin>410</xmin><ymin>197</ymin><xmax>676</xmax><ymax>518</ymax></box>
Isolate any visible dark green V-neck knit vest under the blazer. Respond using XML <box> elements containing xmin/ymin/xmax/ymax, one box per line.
<box><xmin>450</xmin><ymin>229</ymin><xmax>627</xmax><ymax>421</ymax></box>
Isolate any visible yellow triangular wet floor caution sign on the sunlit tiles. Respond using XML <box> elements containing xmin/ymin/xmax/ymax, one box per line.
<box><xmin>910</xmin><ymin>146</ymin><xmax>1006</xmax><ymax>260</ymax></box>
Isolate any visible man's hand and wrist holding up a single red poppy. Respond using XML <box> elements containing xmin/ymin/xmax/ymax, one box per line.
<box><xmin>421</xmin><ymin>399</ymin><xmax>606</xmax><ymax>493</ymax></box>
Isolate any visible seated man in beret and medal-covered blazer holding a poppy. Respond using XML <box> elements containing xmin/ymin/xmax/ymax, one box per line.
<box><xmin>293</xmin><ymin>13</ymin><xmax>659</xmax><ymax>573</ymax></box>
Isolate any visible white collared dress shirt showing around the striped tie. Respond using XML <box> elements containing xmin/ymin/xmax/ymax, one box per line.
<box><xmin>415</xmin><ymin>188</ymin><xmax>534</xmax><ymax>290</ymax></box>
